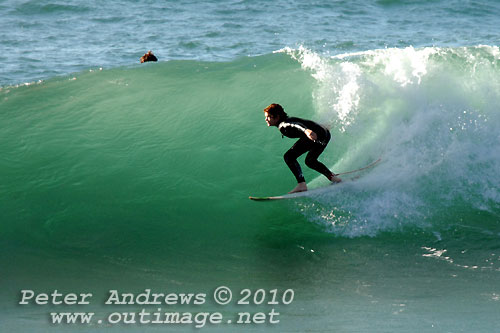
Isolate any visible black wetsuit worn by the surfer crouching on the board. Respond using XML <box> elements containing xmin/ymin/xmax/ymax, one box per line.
<box><xmin>278</xmin><ymin>117</ymin><xmax>333</xmax><ymax>183</ymax></box>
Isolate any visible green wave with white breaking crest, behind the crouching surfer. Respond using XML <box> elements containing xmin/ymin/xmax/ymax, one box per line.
<box><xmin>0</xmin><ymin>46</ymin><xmax>500</xmax><ymax>261</ymax></box>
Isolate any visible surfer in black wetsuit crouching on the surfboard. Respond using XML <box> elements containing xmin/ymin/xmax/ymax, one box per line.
<box><xmin>264</xmin><ymin>103</ymin><xmax>342</xmax><ymax>193</ymax></box>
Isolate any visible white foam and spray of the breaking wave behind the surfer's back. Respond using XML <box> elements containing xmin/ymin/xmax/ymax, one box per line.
<box><xmin>283</xmin><ymin>46</ymin><xmax>500</xmax><ymax>237</ymax></box>
